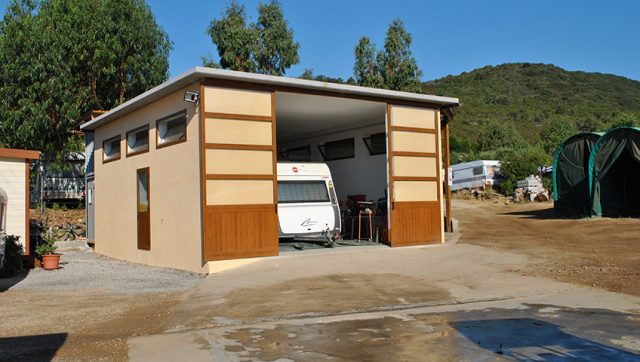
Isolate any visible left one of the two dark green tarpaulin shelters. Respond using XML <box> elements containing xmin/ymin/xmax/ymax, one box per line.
<box><xmin>553</xmin><ymin>132</ymin><xmax>604</xmax><ymax>216</ymax></box>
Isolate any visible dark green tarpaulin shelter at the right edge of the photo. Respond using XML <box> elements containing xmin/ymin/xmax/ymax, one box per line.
<box><xmin>589</xmin><ymin>127</ymin><xmax>640</xmax><ymax>217</ymax></box>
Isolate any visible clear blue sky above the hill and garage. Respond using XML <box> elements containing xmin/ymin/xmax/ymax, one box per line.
<box><xmin>0</xmin><ymin>0</ymin><xmax>640</xmax><ymax>80</ymax></box>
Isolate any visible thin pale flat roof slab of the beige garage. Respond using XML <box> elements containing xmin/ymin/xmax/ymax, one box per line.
<box><xmin>80</xmin><ymin>67</ymin><xmax>460</xmax><ymax>130</ymax></box>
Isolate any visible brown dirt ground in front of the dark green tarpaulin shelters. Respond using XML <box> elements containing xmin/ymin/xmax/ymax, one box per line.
<box><xmin>452</xmin><ymin>200</ymin><xmax>640</xmax><ymax>296</ymax></box>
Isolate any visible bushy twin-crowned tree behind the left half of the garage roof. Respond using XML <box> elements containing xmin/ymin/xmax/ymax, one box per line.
<box><xmin>204</xmin><ymin>0</ymin><xmax>300</xmax><ymax>75</ymax></box>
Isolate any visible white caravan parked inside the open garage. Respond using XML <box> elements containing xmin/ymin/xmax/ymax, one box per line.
<box><xmin>278</xmin><ymin>162</ymin><xmax>341</xmax><ymax>243</ymax></box>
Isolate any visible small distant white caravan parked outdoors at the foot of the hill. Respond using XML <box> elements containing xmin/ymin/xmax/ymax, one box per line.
<box><xmin>451</xmin><ymin>160</ymin><xmax>500</xmax><ymax>191</ymax></box>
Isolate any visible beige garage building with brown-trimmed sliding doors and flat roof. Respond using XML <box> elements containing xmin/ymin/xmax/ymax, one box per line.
<box><xmin>81</xmin><ymin>67</ymin><xmax>458</xmax><ymax>273</ymax></box>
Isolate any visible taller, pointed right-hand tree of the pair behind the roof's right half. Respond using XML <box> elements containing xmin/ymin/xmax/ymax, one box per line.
<box><xmin>378</xmin><ymin>19</ymin><xmax>422</xmax><ymax>92</ymax></box>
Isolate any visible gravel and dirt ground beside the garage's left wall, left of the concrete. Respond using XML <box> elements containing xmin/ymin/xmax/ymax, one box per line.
<box><xmin>0</xmin><ymin>251</ymin><xmax>202</xmax><ymax>361</ymax></box>
